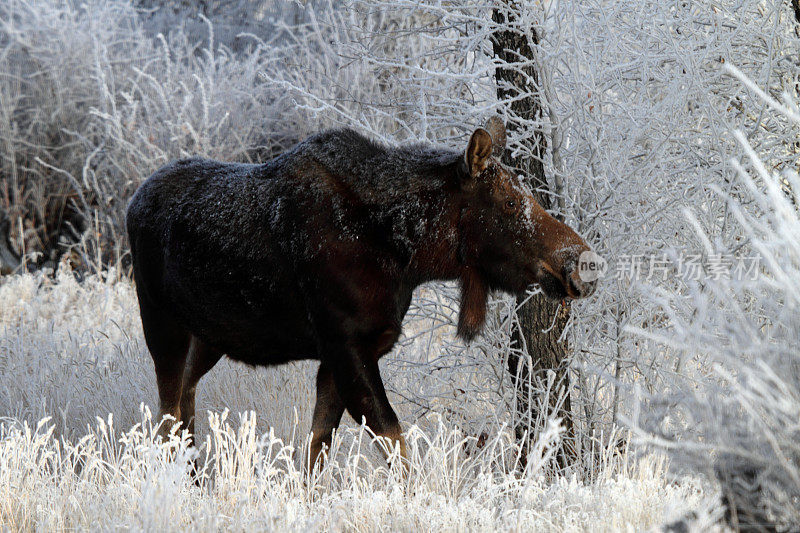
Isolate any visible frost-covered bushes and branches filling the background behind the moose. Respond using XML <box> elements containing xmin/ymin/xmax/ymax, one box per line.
<box><xmin>0</xmin><ymin>0</ymin><xmax>800</xmax><ymax>524</ymax></box>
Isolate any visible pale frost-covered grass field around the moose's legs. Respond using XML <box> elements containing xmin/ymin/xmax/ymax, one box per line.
<box><xmin>0</xmin><ymin>274</ymin><xmax>717</xmax><ymax>531</ymax></box>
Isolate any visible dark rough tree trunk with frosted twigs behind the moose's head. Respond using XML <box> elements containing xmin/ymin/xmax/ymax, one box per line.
<box><xmin>492</xmin><ymin>0</ymin><xmax>575</xmax><ymax>467</ymax></box>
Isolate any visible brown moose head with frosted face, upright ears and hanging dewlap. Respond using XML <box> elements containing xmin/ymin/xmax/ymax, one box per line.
<box><xmin>458</xmin><ymin>117</ymin><xmax>596</xmax><ymax>338</ymax></box>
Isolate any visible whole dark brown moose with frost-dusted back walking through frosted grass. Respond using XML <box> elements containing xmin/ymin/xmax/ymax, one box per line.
<box><xmin>126</xmin><ymin>117</ymin><xmax>595</xmax><ymax>465</ymax></box>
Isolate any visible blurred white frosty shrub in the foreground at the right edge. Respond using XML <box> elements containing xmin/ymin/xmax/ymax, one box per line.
<box><xmin>637</xmin><ymin>67</ymin><xmax>800</xmax><ymax>529</ymax></box>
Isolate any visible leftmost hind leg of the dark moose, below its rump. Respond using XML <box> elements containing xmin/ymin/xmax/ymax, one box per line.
<box><xmin>139</xmin><ymin>294</ymin><xmax>189</xmax><ymax>437</ymax></box>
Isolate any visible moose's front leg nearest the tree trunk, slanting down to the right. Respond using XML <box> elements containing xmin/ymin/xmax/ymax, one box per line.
<box><xmin>325</xmin><ymin>344</ymin><xmax>408</xmax><ymax>463</ymax></box>
